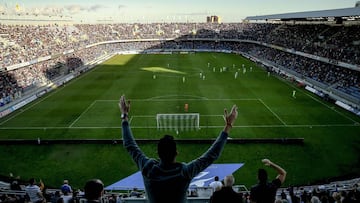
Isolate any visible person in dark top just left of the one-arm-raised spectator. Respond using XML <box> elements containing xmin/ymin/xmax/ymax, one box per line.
<box><xmin>210</xmin><ymin>175</ymin><xmax>242</xmax><ymax>203</ymax></box>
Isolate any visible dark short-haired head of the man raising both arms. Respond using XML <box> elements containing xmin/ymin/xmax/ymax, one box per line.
<box><xmin>158</xmin><ymin>135</ymin><xmax>177</xmax><ymax>163</ymax></box>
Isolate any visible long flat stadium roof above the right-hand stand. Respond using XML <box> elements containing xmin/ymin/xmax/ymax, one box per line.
<box><xmin>245</xmin><ymin>7</ymin><xmax>360</xmax><ymax>20</ymax></box>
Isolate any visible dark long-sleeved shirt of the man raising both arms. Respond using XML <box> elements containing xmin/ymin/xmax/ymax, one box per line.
<box><xmin>122</xmin><ymin>121</ymin><xmax>228</xmax><ymax>203</ymax></box>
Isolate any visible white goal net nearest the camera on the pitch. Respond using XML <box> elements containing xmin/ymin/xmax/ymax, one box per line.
<box><xmin>156</xmin><ymin>113</ymin><xmax>200</xmax><ymax>131</ymax></box>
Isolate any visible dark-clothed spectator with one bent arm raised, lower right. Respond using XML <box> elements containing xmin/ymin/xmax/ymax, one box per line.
<box><xmin>250</xmin><ymin>159</ymin><xmax>286</xmax><ymax>203</ymax></box>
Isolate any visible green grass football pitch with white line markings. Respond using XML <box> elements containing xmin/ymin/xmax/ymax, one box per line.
<box><xmin>0</xmin><ymin>53</ymin><xmax>360</xmax><ymax>188</ymax></box>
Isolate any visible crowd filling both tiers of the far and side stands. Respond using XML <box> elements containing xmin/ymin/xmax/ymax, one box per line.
<box><xmin>0</xmin><ymin>23</ymin><xmax>360</xmax><ymax>107</ymax></box>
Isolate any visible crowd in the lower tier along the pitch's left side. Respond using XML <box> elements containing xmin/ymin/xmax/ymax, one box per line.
<box><xmin>0</xmin><ymin>44</ymin><xmax>119</xmax><ymax>107</ymax></box>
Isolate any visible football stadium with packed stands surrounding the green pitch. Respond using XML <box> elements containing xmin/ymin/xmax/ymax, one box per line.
<box><xmin>0</xmin><ymin>0</ymin><xmax>360</xmax><ymax>203</ymax></box>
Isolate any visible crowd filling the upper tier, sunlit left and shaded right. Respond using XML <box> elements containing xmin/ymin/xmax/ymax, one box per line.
<box><xmin>0</xmin><ymin>23</ymin><xmax>360</xmax><ymax>67</ymax></box>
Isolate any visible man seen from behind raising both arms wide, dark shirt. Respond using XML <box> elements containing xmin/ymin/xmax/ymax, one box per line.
<box><xmin>119</xmin><ymin>96</ymin><xmax>237</xmax><ymax>203</ymax></box>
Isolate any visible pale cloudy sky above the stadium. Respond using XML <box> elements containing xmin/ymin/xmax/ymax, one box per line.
<box><xmin>0</xmin><ymin>0</ymin><xmax>357</xmax><ymax>23</ymax></box>
